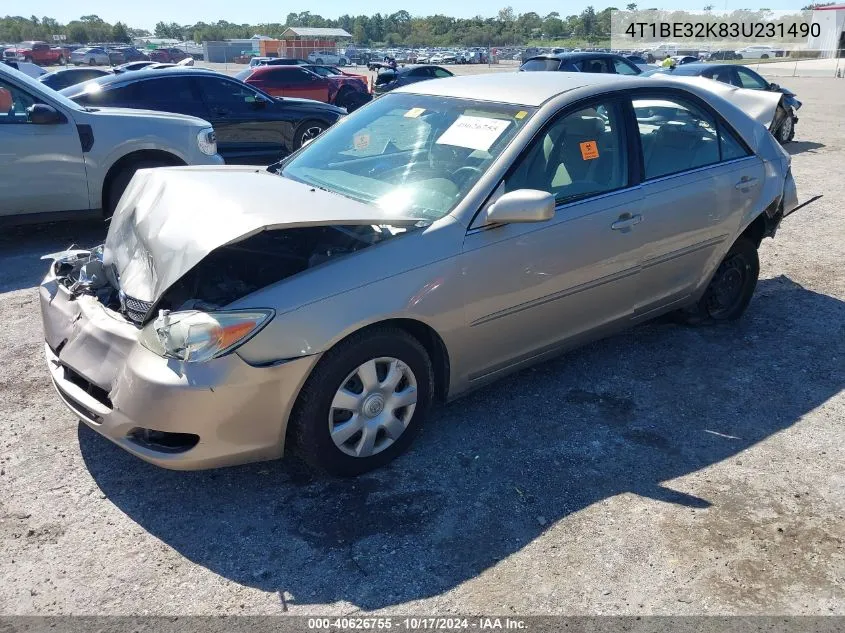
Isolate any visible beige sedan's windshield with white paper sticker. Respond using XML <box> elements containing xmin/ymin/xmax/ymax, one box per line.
<box><xmin>282</xmin><ymin>94</ymin><xmax>535</xmax><ymax>221</ymax></box>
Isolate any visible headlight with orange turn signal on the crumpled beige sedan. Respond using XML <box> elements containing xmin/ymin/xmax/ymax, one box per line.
<box><xmin>138</xmin><ymin>310</ymin><xmax>275</xmax><ymax>363</ymax></box>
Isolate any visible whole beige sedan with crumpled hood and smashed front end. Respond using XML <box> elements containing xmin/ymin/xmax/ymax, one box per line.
<box><xmin>40</xmin><ymin>73</ymin><xmax>812</xmax><ymax>475</ymax></box>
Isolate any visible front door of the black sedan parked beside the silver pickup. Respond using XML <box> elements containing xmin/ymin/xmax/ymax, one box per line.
<box><xmin>192</xmin><ymin>74</ymin><xmax>286</xmax><ymax>165</ymax></box>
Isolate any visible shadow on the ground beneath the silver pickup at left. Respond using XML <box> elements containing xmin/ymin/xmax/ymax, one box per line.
<box><xmin>0</xmin><ymin>220</ymin><xmax>108</xmax><ymax>292</ymax></box>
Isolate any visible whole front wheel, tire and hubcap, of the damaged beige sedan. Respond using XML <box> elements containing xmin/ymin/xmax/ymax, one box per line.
<box><xmin>288</xmin><ymin>327</ymin><xmax>434</xmax><ymax>477</ymax></box>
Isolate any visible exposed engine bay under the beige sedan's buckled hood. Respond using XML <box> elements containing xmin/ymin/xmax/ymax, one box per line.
<box><xmin>42</xmin><ymin>225</ymin><xmax>406</xmax><ymax>326</ymax></box>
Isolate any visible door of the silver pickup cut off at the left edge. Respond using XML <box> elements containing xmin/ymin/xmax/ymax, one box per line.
<box><xmin>0</xmin><ymin>77</ymin><xmax>89</xmax><ymax>215</ymax></box>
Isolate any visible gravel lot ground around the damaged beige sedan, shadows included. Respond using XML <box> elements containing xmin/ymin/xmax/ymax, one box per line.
<box><xmin>0</xmin><ymin>79</ymin><xmax>845</xmax><ymax>615</ymax></box>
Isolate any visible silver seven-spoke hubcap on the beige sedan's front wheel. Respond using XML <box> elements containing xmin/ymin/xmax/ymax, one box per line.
<box><xmin>328</xmin><ymin>357</ymin><xmax>417</xmax><ymax>457</ymax></box>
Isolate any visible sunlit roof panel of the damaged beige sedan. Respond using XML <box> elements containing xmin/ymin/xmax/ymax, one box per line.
<box><xmin>394</xmin><ymin>72</ymin><xmax>640</xmax><ymax>106</ymax></box>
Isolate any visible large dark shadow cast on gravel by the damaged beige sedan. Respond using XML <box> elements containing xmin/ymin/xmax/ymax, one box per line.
<box><xmin>78</xmin><ymin>277</ymin><xmax>845</xmax><ymax>609</ymax></box>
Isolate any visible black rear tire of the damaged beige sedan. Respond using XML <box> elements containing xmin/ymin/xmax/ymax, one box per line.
<box><xmin>676</xmin><ymin>237</ymin><xmax>760</xmax><ymax>325</ymax></box>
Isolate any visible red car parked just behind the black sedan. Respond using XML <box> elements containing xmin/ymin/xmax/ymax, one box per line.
<box><xmin>235</xmin><ymin>66</ymin><xmax>372</xmax><ymax>112</ymax></box>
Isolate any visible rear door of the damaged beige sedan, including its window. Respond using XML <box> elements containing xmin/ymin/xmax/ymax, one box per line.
<box><xmin>632</xmin><ymin>90</ymin><xmax>764</xmax><ymax>318</ymax></box>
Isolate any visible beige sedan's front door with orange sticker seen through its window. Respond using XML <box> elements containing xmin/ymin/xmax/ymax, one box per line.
<box><xmin>462</xmin><ymin>99</ymin><xmax>642</xmax><ymax>382</ymax></box>
